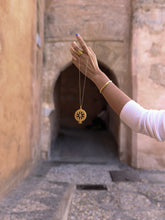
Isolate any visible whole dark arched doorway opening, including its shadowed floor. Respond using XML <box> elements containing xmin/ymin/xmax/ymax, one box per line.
<box><xmin>50</xmin><ymin>62</ymin><xmax>119</xmax><ymax>162</ymax></box>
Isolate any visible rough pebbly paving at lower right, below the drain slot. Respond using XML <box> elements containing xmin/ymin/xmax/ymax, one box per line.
<box><xmin>68</xmin><ymin>170</ymin><xmax>165</xmax><ymax>220</ymax></box>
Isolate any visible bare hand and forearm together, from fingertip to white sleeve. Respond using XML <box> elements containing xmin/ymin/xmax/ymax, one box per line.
<box><xmin>70</xmin><ymin>34</ymin><xmax>131</xmax><ymax>115</ymax></box>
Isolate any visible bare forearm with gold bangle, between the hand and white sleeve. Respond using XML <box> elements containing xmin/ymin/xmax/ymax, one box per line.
<box><xmin>91</xmin><ymin>70</ymin><xmax>131</xmax><ymax>115</ymax></box>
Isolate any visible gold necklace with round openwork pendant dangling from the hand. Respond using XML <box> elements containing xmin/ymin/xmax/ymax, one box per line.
<box><xmin>74</xmin><ymin>59</ymin><xmax>88</xmax><ymax>124</ymax></box>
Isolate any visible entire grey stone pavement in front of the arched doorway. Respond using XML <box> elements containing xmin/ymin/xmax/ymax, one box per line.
<box><xmin>0</xmin><ymin>128</ymin><xmax>165</xmax><ymax>220</ymax></box>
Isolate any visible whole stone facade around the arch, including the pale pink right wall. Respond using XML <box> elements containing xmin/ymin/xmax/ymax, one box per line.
<box><xmin>42</xmin><ymin>0</ymin><xmax>165</xmax><ymax>169</ymax></box>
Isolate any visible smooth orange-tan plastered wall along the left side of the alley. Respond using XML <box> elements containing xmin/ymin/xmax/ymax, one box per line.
<box><xmin>0</xmin><ymin>0</ymin><xmax>43</xmax><ymax>196</ymax></box>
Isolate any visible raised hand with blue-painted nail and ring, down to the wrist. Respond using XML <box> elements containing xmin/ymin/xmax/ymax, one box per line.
<box><xmin>70</xmin><ymin>34</ymin><xmax>100</xmax><ymax>81</ymax></box>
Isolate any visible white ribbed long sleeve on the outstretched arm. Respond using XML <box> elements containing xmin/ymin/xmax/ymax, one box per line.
<box><xmin>120</xmin><ymin>100</ymin><xmax>165</xmax><ymax>141</ymax></box>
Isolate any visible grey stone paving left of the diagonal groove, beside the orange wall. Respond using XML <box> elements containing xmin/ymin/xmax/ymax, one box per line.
<box><xmin>0</xmin><ymin>163</ymin><xmax>73</xmax><ymax>220</ymax></box>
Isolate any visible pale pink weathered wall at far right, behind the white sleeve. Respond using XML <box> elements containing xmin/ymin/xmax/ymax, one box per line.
<box><xmin>132</xmin><ymin>0</ymin><xmax>165</xmax><ymax>169</ymax></box>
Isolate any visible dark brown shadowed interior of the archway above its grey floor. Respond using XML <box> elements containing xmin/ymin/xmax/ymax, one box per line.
<box><xmin>50</xmin><ymin>62</ymin><xmax>119</xmax><ymax>143</ymax></box>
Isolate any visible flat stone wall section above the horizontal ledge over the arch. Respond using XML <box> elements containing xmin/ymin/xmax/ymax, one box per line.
<box><xmin>46</xmin><ymin>0</ymin><xmax>130</xmax><ymax>41</ymax></box>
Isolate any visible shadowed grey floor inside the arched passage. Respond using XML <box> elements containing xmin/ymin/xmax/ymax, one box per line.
<box><xmin>51</xmin><ymin>128</ymin><xmax>117</xmax><ymax>163</ymax></box>
